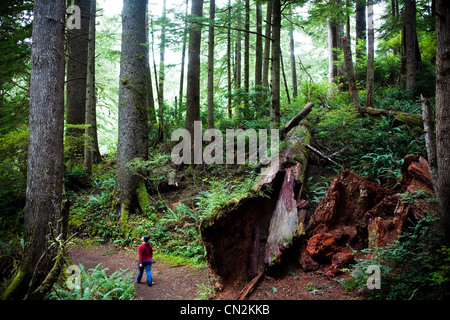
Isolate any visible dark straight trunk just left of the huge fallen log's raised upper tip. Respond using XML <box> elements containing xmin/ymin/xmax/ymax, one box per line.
<box><xmin>270</xmin><ymin>0</ymin><xmax>281</xmax><ymax>128</ymax></box>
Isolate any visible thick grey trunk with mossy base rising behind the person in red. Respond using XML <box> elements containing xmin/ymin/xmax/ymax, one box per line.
<box><xmin>115</xmin><ymin>0</ymin><xmax>148</xmax><ymax>233</ymax></box>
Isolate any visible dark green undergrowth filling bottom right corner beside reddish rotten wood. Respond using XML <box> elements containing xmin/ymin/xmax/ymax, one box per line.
<box><xmin>344</xmin><ymin>218</ymin><xmax>450</xmax><ymax>300</ymax></box>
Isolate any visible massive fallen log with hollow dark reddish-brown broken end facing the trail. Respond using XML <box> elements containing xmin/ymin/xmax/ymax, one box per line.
<box><xmin>200</xmin><ymin>120</ymin><xmax>311</xmax><ymax>299</ymax></box>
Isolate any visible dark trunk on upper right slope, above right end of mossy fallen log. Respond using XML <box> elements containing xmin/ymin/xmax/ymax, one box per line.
<box><xmin>404</xmin><ymin>0</ymin><xmax>416</xmax><ymax>90</ymax></box>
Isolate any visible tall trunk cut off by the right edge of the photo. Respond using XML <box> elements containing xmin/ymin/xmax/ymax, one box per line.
<box><xmin>436</xmin><ymin>0</ymin><xmax>450</xmax><ymax>246</ymax></box>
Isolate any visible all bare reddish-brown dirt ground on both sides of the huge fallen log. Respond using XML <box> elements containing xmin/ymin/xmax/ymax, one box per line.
<box><xmin>69</xmin><ymin>244</ymin><xmax>357</xmax><ymax>300</ymax></box>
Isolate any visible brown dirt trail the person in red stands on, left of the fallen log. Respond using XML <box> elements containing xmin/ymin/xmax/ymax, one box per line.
<box><xmin>69</xmin><ymin>245</ymin><xmax>208</xmax><ymax>300</ymax></box>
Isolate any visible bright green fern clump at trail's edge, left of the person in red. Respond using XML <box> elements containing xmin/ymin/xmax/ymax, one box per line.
<box><xmin>49</xmin><ymin>264</ymin><xmax>136</xmax><ymax>300</ymax></box>
